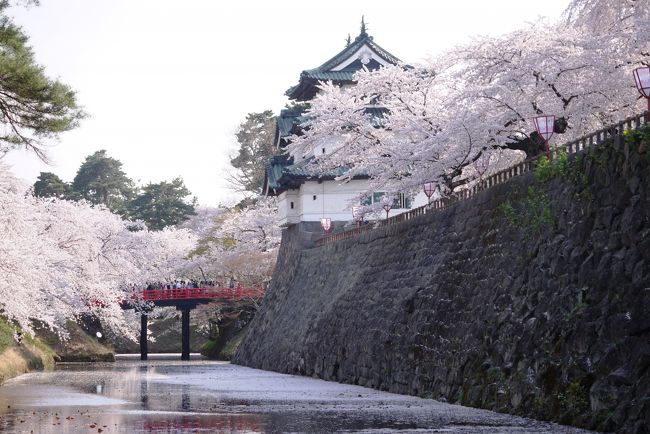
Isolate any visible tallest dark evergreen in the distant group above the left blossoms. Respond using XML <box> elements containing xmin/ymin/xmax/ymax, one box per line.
<box><xmin>72</xmin><ymin>149</ymin><xmax>134</xmax><ymax>214</ymax></box>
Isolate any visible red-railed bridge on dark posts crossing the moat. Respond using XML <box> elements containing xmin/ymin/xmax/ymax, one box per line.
<box><xmin>121</xmin><ymin>286</ymin><xmax>264</xmax><ymax>360</ymax></box>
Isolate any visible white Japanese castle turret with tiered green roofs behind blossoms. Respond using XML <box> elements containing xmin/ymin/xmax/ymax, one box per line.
<box><xmin>264</xmin><ymin>19</ymin><xmax>420</xmax><ymax>226</ymax></box>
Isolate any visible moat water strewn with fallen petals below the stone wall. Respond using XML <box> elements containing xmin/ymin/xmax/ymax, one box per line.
<box><xmin>0</xmin><ymin>357</ymin><xmax>584</xmax><ymax>434</ymax></box>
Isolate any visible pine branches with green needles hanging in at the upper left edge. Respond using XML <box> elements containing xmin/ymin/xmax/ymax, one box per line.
<box><xmin>0</xmin><ymin>0</ymin><xmax>84</xmax><ymax>160</ymax></box>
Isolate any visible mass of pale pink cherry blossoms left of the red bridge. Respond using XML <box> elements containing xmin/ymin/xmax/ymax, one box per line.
<box><xmin>0</xmin><ymin>165</ymin><xmax>196</xmax><ymax>335</ymax></box>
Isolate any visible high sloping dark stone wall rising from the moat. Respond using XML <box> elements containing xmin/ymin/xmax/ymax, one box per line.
<box><xmin>234</xmin><ymin>141</ymin><xmax>650</xmax><ymax>432</ymax></box>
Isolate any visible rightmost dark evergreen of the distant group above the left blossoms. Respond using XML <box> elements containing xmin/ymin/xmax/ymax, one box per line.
<box><xmin>127</xmin><ymin>178</ymin><xmax>196</xmax><ymax>231</ymax></box>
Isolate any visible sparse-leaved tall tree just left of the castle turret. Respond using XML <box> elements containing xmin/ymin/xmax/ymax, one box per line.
<box><xmin>229</xmin><ymin>110</ymin><xmax>276</xmax><ymax>194</ymax></box>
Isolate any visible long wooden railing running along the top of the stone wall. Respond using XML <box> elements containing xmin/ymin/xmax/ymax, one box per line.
<box><xmin>316</xmin><ymin>112</ymin><xmax>649</xmax><ymax>246</ymax></box>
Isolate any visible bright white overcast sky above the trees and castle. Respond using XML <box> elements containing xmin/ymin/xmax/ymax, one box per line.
<box><xmin>6</xmin><ymin>0</ymin><xmax>569</xmax><ymax>205</ymax></box>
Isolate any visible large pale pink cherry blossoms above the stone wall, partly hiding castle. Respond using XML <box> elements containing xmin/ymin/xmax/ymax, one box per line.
<box><xmin>289</xmin><ymin>0</ymin><xmax>650</xmax><ymax>194</ymax></box>
